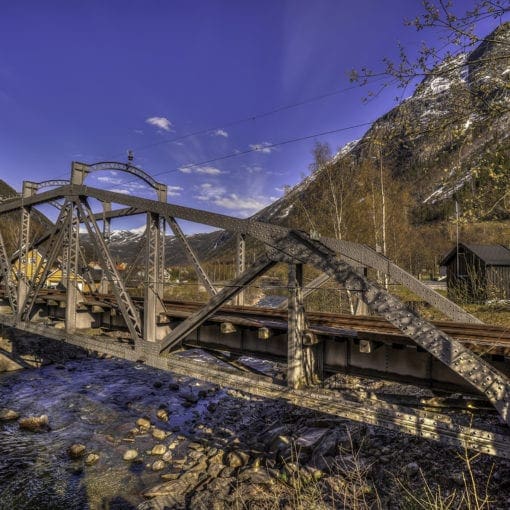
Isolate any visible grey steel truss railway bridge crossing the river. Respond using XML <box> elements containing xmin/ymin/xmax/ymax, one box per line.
<box><xmin>0</xmin><ymin>162</ymin><xmax>510</xmax><ymax>458</ymax></box>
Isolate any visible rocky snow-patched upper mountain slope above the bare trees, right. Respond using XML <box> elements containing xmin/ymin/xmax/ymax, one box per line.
<box><xmin>256</xmin><ymin>23</ymin><xmax>510</xmax><ymax>225</ymax></box>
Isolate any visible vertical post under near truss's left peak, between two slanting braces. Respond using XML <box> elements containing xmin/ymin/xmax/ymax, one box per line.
<box><xmin>64</xmin><ymin>204</ymin><xmax>80</xmax><ymax>333</ymax></box>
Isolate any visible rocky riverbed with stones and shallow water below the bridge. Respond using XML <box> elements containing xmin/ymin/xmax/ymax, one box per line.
<box><xmin>0</xmin><ymin>358</ymin><xmax>510</xmax><ymax>510</ymax></box>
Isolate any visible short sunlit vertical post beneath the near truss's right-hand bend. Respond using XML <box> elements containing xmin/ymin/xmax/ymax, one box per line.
<box><xmin>287</xmin><ymin>264</ymin><xmax>305</xmax><ymax>389</ymax></box>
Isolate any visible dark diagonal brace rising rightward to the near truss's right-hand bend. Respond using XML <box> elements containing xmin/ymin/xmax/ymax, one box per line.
<box><xmin>160</xmin><ymin>255</ymin><xmax>277</xmax><ymax>354</ymax></box>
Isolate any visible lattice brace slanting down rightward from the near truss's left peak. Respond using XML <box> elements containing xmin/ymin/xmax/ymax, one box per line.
<box><xmin>75</xmin><ymin>197</ymin><xmax>143</xmax><ymax>343</ymax></box>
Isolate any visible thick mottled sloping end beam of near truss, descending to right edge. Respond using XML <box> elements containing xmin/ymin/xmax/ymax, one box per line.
<box><xmin>274</xmin><ymin>231</ymin><xmax>510</xmax><ymax>424</ymax></box>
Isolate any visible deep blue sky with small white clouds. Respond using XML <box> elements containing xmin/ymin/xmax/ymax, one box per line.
<box><xmin>0</xmin><ymin>0</ymin><xmax>506</xmax><ymax>232</ymax></box>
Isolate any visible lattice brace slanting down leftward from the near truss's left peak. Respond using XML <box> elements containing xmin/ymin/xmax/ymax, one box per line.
<box><xmin>18</xmin><ymin>202</ymin><xmax>71</xmax><ymax>320</ymax></box>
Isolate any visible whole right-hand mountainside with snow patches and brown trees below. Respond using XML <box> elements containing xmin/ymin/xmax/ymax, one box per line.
<box><xmin>251</xmin><ymin>23</ymin><xmax>510</xmax><ymax>273</ymax></box>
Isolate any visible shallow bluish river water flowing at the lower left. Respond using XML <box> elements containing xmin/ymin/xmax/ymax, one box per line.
<box><xmin>0</xmin><ymin>358</ymin><xmax>230</xmax><ymax>510</ymax></box>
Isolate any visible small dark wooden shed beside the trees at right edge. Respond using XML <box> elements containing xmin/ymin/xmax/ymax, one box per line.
<box><xmin>441</xmin><ymin>243</ymin><xmax>510</xmax><ymax>303</ymax></box>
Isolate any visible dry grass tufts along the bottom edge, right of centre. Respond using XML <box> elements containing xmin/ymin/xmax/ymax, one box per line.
<box><xmin>234</xmin><ymin>428</ymin><xmax>493</xmax><ymax>510</ymax></box>
